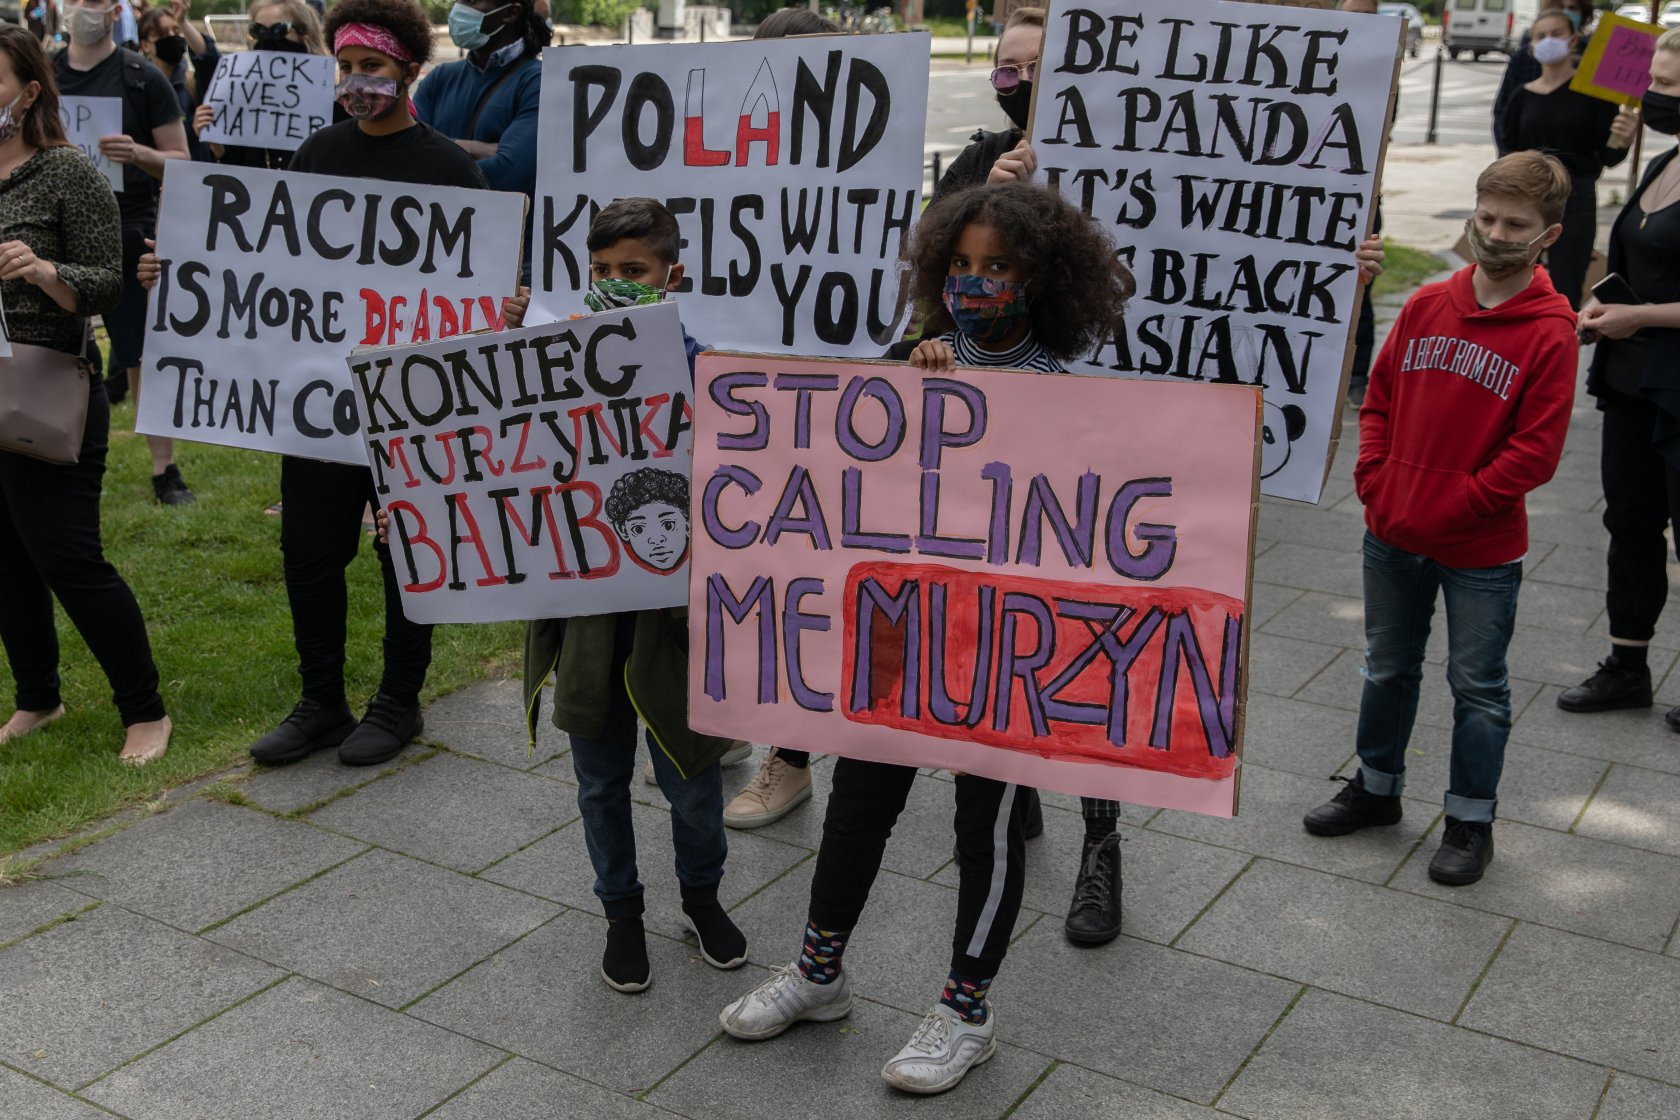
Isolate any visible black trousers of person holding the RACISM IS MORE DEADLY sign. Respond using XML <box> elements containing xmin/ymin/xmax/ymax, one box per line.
<box><xmin>281</xmin><ymin>455</ymin><xmax>432</xmax><ymax>705</ymax></box>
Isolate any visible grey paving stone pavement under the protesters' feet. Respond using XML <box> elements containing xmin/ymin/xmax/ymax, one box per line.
<box><xmin>0</xmin><ymin>376</ymin><xmax>1680</xmax><ymax>1120</ymax></box>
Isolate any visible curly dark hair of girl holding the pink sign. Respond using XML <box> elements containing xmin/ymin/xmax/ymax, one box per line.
<box><xmin>907</xmin><ymin>183</ymin><xmax>1137</xmax><ymax>361</ymax></box>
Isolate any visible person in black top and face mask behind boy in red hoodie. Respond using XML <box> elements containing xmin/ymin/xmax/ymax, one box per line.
<box><xmin>1499</xmin><ymin>10</ymin><xmax>1633</xmax><ymax>311</ymax></box>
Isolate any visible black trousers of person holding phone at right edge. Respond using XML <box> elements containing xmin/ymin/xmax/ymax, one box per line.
<box><xmin>1599</xmin><ymin>389</ymin><xmax>1680</xmax><ymax>641</ymax></box>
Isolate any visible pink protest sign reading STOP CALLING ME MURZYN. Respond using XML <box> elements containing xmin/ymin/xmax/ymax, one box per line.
<box><xmin>689</xmin><ymin>354</ymin><xmax>1262</xmax><ymax>816</ymax></box>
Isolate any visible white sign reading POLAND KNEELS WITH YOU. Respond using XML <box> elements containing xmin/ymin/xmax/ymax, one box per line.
<box><xmin>531</xmin><ymin>34</ymin><xmax>927</xmax><ymax>358</ymax></box>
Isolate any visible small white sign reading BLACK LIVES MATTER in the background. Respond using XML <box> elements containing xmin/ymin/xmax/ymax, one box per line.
<box><xmin>198</xmin><ymin>50</ymin><xmax>338</xmax><ymax>151</ymax></box>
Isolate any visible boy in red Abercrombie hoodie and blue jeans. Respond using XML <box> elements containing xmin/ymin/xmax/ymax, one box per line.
<box><xmin>1304</xmin><ymin>151</ymin><xmax>1576</xmax><ymax>885</ymax></box>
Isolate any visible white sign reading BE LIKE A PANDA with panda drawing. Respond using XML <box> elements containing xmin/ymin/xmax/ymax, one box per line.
<box><xmin>1032</xmin><ymin>0</ymin><xmax>1399</xmax><ymax>502</ymax></box>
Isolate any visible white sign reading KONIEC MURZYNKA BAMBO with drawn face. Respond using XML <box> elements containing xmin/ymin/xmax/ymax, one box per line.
<box><xmin>348</xmin><ymin>304</ymin><xmax>694</xmax><ymax>623</ymax></box>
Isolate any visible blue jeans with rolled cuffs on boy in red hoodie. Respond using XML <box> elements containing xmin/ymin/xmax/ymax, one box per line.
<box><xmin>1357</xmin><ymin>532</ymin><xmax>1522</xmax><ymax>821</ymax></box>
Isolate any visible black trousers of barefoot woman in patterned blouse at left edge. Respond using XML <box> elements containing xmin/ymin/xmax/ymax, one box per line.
<box><xmin>0</xmin><ymin>378</ymin><xmax>165</xmax><ymax>725</ymax></box>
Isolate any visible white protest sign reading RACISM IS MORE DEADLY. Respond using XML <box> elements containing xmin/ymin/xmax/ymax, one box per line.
<box><xmin>134</xmin><ymin>160</ymin><xmax>524</xmax><ymax>463</ymax></box>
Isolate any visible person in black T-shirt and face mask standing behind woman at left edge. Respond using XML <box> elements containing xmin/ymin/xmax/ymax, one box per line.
<box><xmin>52</xmin><ymin>0</ymin><xmax>193</xmax><ymax>505</ymax></box>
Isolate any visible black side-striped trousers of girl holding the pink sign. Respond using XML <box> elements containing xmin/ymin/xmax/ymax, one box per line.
<box><xmin>810</xmin><ymin>759</ymin><xmax>1026</xmax><ymax>977</ymax></box>
